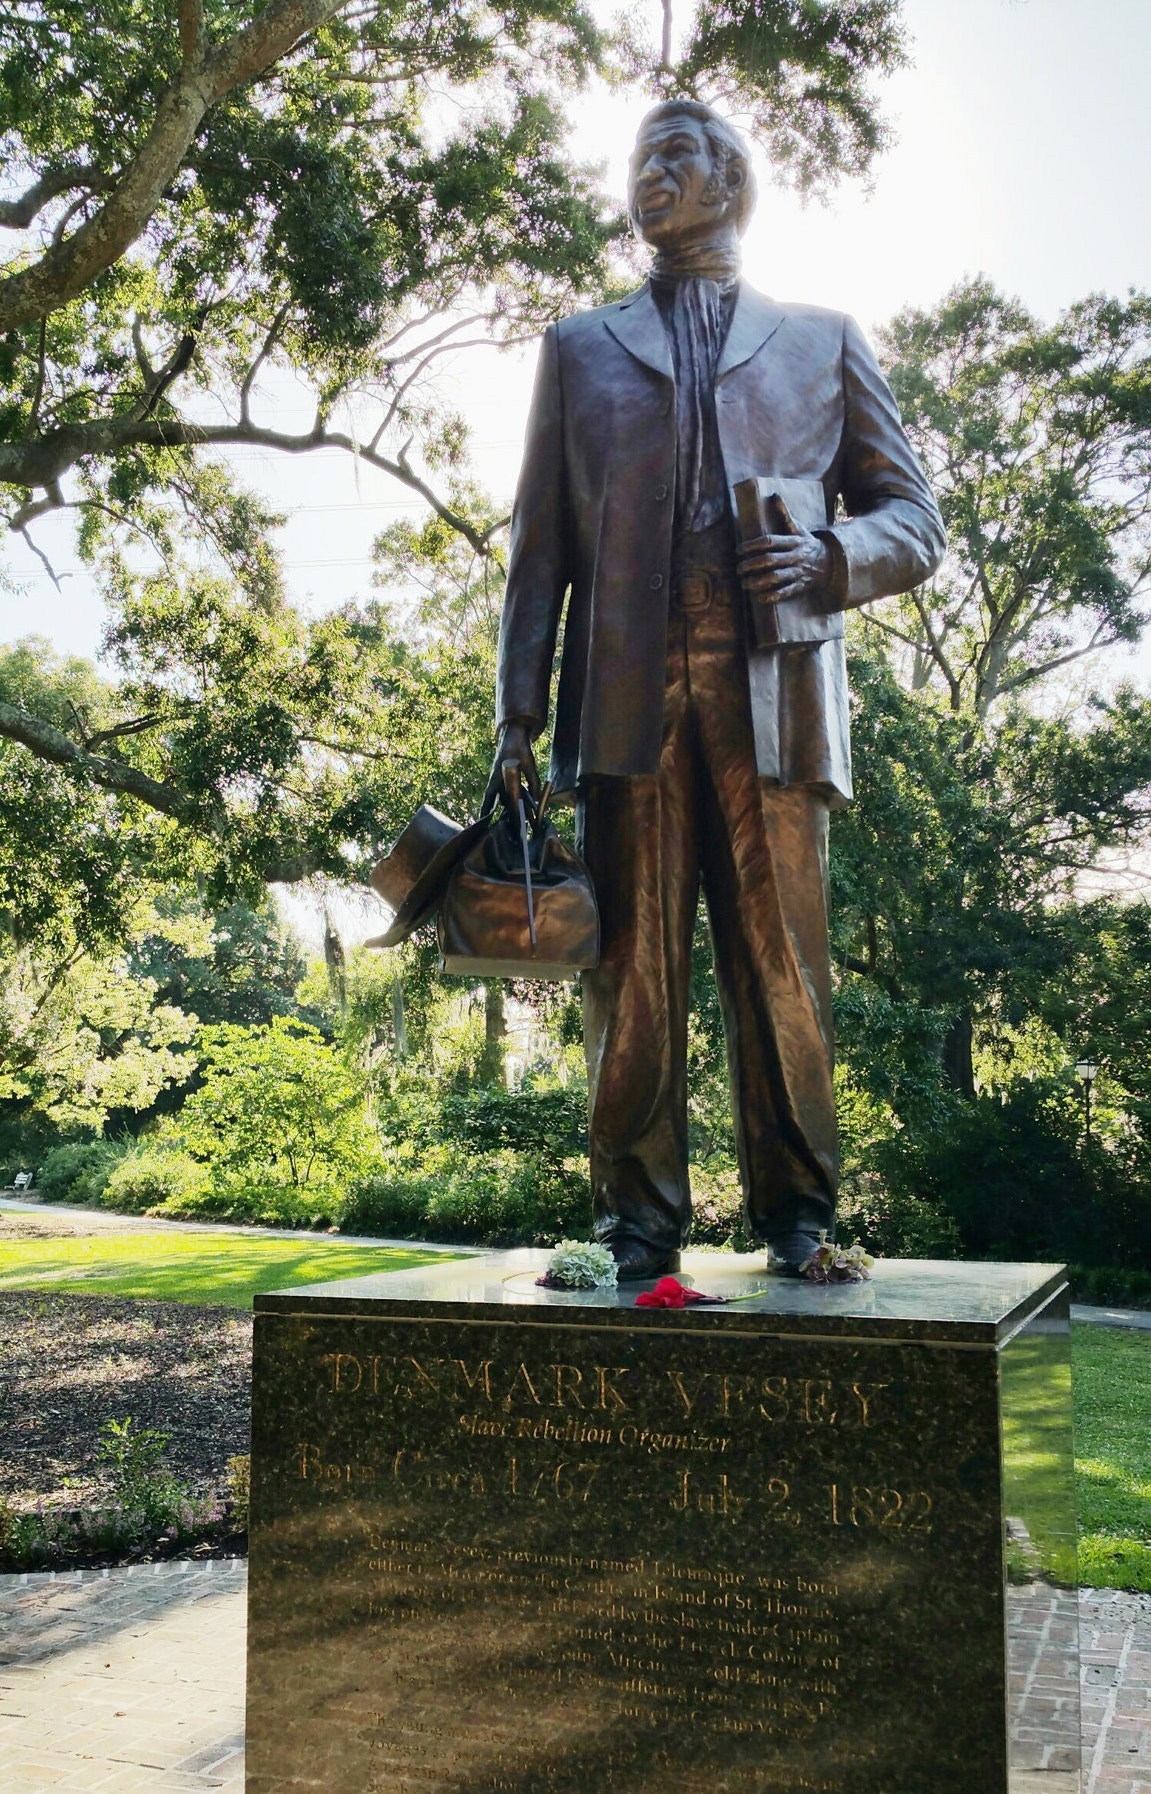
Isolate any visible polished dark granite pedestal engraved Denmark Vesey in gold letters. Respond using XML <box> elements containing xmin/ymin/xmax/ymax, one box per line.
<box><xmin>247</xmin><ymin>1252</ymin><xmax>1079</xmax><ymax>1794</ymax></box>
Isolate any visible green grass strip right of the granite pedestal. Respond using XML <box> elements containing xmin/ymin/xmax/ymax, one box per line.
<box><xmin>1072</xmin><ymin>1326</ymin><xmax>1151</xmax><ymax>1589</ymax></box>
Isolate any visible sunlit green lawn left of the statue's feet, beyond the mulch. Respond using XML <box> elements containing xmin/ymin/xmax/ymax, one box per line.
<box><xmin>0</xmin><ymin>1231</ymin><xmax>445</xmax><ymax>1308</ymax></box>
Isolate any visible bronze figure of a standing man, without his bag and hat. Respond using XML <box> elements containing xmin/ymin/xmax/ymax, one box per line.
<box><xmin>484</xmin><ymin>100</ymin><xmax>945</xmax><ymax>1279</ymax></box>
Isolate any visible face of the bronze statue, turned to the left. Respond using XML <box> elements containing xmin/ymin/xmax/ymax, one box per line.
<box><xmin>627</xmin><ymin>115</ymin><xmax>742</xmax><ymax>249</ymax></box>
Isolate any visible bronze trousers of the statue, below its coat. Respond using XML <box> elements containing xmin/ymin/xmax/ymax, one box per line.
<box><xmin>577</xmin><ymin>533</ymin><xmax>839</xmax><ymax>1249</ymax></box>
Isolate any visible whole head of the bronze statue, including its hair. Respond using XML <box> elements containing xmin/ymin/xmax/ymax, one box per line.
<box><xmin>627</xmin><ymin>100</ymin><xmax>755</xmax><ymax>249</ymax></box>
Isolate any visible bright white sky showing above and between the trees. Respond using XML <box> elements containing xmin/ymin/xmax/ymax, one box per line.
<box><xmin>0</xmin><ymin>0</ymin><xmax>1151</xmax><ymax>671</ymax></box>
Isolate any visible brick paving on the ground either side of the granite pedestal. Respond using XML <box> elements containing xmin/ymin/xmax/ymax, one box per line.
<box><xmin>0</xmin><ymin>1561</ymin><xmax>1151</xmax><ymax>1794</ymax></box>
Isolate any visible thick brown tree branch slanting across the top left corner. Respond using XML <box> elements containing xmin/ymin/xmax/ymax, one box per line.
<box><xmin>0</xmin><ymin>0</ymin><xmax>346</xmax><ymax>334</ymax></box>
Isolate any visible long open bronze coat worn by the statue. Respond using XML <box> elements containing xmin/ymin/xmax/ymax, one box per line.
<box><xmin>497</xmin><ymin>283</ymin><xmax>945</xmax><ymax>800</ymax></box>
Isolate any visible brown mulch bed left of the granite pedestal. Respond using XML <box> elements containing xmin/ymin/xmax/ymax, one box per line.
<box><xmin>0</xmin><ymin>1292</ymin><xmax>251</xmax><ymax>1507</ymax></box>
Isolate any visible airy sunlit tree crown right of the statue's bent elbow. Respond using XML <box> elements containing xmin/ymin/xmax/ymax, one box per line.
<box><xmin>878</xmin><ymin>276</ymin><xmax>1151</xmax><ymax>718</ymax></box>
